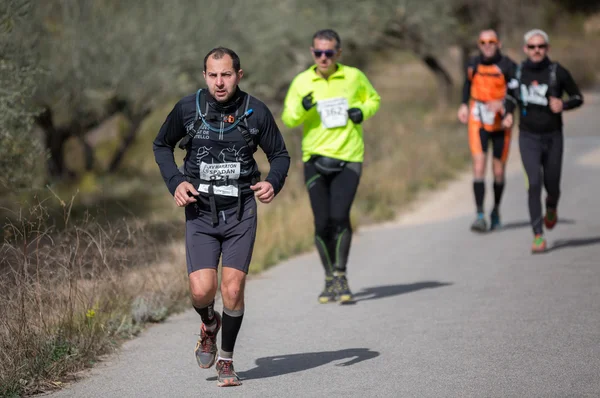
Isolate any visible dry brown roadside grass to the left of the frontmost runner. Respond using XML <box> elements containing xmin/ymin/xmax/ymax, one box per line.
<box><xmin>0</xmin><ymin>204</ymin><xmax>187</xmax><ymax>396</ymax></box>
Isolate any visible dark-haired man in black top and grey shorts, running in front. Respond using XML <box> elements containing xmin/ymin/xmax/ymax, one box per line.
<box><xmin>153</xmin><ymin>47</ymin><xmax>290</xmax><ymax>386</ymax></box>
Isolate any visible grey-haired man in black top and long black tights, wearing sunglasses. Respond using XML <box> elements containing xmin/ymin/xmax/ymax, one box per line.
<box><xmin>506</xmin><ymin>29</ymin><xmax>583</xmax><ymax>253</ymax></box>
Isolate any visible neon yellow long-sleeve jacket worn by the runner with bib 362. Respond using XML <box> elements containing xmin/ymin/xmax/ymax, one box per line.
<box><xmin>281</xmin><ymin>63</ymin><xmax>381</xmax><ymax>162</ymax></box>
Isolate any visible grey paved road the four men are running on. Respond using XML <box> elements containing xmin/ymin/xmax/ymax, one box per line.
<box><xmin>48</xmin><ymin>94</ymin><xmax>600</xmax><ymax>397</ymax></box>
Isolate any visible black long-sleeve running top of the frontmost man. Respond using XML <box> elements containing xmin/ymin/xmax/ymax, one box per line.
<box><xmin>153</xmin><ymin>88</ymin><xmax>290</xmax><ymax>209</ymax></box>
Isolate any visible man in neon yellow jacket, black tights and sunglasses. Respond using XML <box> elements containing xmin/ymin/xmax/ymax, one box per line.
<box><xmin>282</xmin><ymin>29</ymin><xmax>381</xmax><ymax>303</ymax></box>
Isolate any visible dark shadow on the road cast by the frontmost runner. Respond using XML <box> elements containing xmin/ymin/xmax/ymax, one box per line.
<box><xmin>206</xmin><ymin>348</ymin><xmax>379</xmax><ymax>381</ymax></box>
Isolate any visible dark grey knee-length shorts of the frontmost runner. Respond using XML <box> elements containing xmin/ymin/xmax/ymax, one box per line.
<box><xmin>185</xmin><ymin>196</ymin><xmax>257</xmax><ymax>275</ymax></box>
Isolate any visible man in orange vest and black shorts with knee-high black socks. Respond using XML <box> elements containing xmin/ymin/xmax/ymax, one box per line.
<box><xmin>458</xmin><ymin>30</ymin><xmax>517</xmax><ymax>232</ymax></box>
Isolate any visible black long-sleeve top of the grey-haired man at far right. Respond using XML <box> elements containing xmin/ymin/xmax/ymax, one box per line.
<box><xmin>513</xmin><ymin>57</ymin><xmax>583</xmax><ymax>134</ymax></box>
